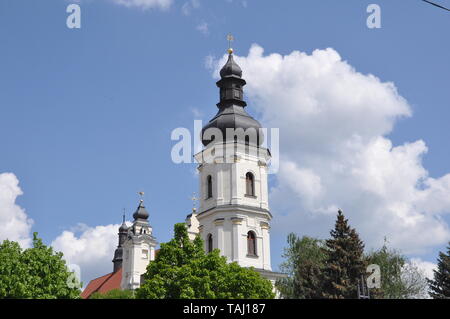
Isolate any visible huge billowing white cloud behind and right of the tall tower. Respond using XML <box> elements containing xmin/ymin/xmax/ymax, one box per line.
<box><xmin>211</xmin><ymin>45</ymin><xmax>450</xmax><ymax>254</ymax></box>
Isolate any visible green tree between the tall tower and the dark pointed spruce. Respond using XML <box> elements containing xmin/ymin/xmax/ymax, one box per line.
<box><xmin>276</xmin><ymin>233</ymin><xmax>326</xmax><ymax>299</ymax></box>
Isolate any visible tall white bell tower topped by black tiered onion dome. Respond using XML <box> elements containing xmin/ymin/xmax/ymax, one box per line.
<box><xmin>189</xmin><ymin>49</ymin><xmax>276</xmax><ymax>280</ymax></box>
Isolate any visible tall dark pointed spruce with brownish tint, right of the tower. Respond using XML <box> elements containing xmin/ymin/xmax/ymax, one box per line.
<box><xmin>323</xmin><ymin>210</ymin><xmax>366</xmax><ymax>299</ymax></box>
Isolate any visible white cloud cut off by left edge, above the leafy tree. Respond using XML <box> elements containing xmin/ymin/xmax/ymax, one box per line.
<box><xmin>0</xmin><ymin>173</ymin><xmax>33</xmax><ymax>248</ymax></box>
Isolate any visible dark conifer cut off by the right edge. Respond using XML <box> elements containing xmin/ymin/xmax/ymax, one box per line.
<box><xmin>428</xmin><ymin>242</ymin><xmax>450</xmax><ymax>299</ymax></box>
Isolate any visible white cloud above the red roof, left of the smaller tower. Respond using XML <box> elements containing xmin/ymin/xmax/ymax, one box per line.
<box><xmin>51</xmin><ymin>224</ymin><xmax>128</xmax><ymax>286</ymax></box>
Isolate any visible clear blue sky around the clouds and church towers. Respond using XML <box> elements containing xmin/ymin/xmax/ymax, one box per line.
<box><xmin>0</xmin><ymin>0</ymin><xmax>450</xmax><ymax>282</ymax></box>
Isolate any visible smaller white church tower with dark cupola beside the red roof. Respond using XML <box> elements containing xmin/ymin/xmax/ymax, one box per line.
<box><xmin>120</xmin><ymin>200</ymin><xmax>157</xmax><ymax>289</ymax></box>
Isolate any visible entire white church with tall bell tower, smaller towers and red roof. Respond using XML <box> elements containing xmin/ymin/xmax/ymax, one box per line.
<box><xmin>82</xmin><ymin>49</ymin><xmax>283</xmax><ymax>298</ymax></box>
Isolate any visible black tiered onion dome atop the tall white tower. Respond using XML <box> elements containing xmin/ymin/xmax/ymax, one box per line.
<box><xmin>202</xmin><ymin>53</ymin><xmax>264</xmax><ymax>146</ymax></box>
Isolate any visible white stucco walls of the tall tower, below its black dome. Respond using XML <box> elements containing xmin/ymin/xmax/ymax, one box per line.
<box><xmin>190</xmin><ymin>142</ymin><xmax>272</xmax><ymax>271</ymax></box>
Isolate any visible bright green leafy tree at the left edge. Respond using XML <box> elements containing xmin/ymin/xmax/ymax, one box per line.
<box><xmin>0</xmin><ymin>233</ymin><xmax>80</xmax><ymax>299</ymax></box>
